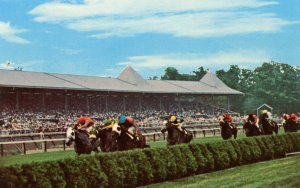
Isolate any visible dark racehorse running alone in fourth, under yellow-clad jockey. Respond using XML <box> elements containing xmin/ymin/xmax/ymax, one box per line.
<box><xmin>163</xmin><ymin>120</ymin><xmax>193</xmax><ymax>146</ymax></box>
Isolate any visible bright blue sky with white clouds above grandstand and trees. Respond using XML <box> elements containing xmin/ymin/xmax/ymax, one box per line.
<box><xmin>0</xmin><ymin>0</ymin><xmax>300</xmax><ymax>78</ymax></box>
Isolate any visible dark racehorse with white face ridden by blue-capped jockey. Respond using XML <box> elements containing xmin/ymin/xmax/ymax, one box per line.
<box><xmin>112</xmin><ymin>123</ymin><xmax>149</xmax><ymax>151</ymax></box>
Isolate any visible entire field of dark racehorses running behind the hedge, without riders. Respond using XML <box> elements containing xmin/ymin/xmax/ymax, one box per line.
<box><xmin>66</xmin><ymin>114</ymin><xmax>298</xmax><ymax>155</ymax></box>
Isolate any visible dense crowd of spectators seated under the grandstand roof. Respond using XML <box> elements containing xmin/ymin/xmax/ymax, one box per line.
<box><xmin>0</xmin><ymin>96</ymin><xmax>246</xmax><ymax>135</ymax></box>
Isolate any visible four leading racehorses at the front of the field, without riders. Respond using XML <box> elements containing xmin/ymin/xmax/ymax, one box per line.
<box><xmin>66</xmin><ymin>120</ymin><xmax>193</xmax><ymax>155</ymax></box>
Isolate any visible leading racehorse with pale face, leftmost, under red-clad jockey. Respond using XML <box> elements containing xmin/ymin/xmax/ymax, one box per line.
<box><xmin>66</xmin><ymin>127</ymin><xmax>99</xmax><ymax>155</ymax></box>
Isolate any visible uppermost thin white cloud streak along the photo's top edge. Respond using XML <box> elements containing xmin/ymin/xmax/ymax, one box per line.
<box><xmin>29</xmin><ymin>0</ymin><xmax>278</xmax><ymax>22</ymax></box>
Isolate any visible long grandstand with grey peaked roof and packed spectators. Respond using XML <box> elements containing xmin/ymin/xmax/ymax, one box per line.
<box><xmin>0</xmin><ymin>66</ymin><xmax>242</xmax><ymax>134</ymax></box>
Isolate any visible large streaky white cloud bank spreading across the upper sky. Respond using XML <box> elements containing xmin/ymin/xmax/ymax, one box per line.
<box><xmin>29</xmin><ymin>0</ymin><xmax>299</xmax><ymax>39</ymax></box>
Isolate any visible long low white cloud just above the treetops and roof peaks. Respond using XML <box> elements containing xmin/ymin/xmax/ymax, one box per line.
<box><xmin>117</xmin><ymin>50</ymin><xmax>270</xmax><ymax>69</ymax></box>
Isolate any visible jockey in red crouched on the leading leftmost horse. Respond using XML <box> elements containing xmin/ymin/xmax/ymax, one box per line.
<box><xmin>75</xmin><ymin>115</ymin><xmax>96</xmax><ymax>139</ymax></box>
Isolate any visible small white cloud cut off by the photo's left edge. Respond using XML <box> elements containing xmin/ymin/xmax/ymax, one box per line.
<box><xmin>0</xmin><ymin>21</ymin><xmax>29</xmax><ymax>44</ymax></box>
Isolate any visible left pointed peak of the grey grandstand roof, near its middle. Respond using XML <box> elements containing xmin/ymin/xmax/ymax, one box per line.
<box><xmin>118</xmin><ymin>66</ymin><xmax>147</xmax><ymax>85</ymax></box>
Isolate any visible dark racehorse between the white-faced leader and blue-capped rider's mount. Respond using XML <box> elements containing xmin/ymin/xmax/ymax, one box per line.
<box><xmin>98</xmin><ymin>127</ymin><xmax>118</xmax><ymax>152</ymax></box>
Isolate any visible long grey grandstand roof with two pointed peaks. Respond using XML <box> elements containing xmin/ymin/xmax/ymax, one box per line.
<box><xmin>0</xmin><ymin>66</ymin><xmax>243</xmax><ymax>95</ymax></box>
